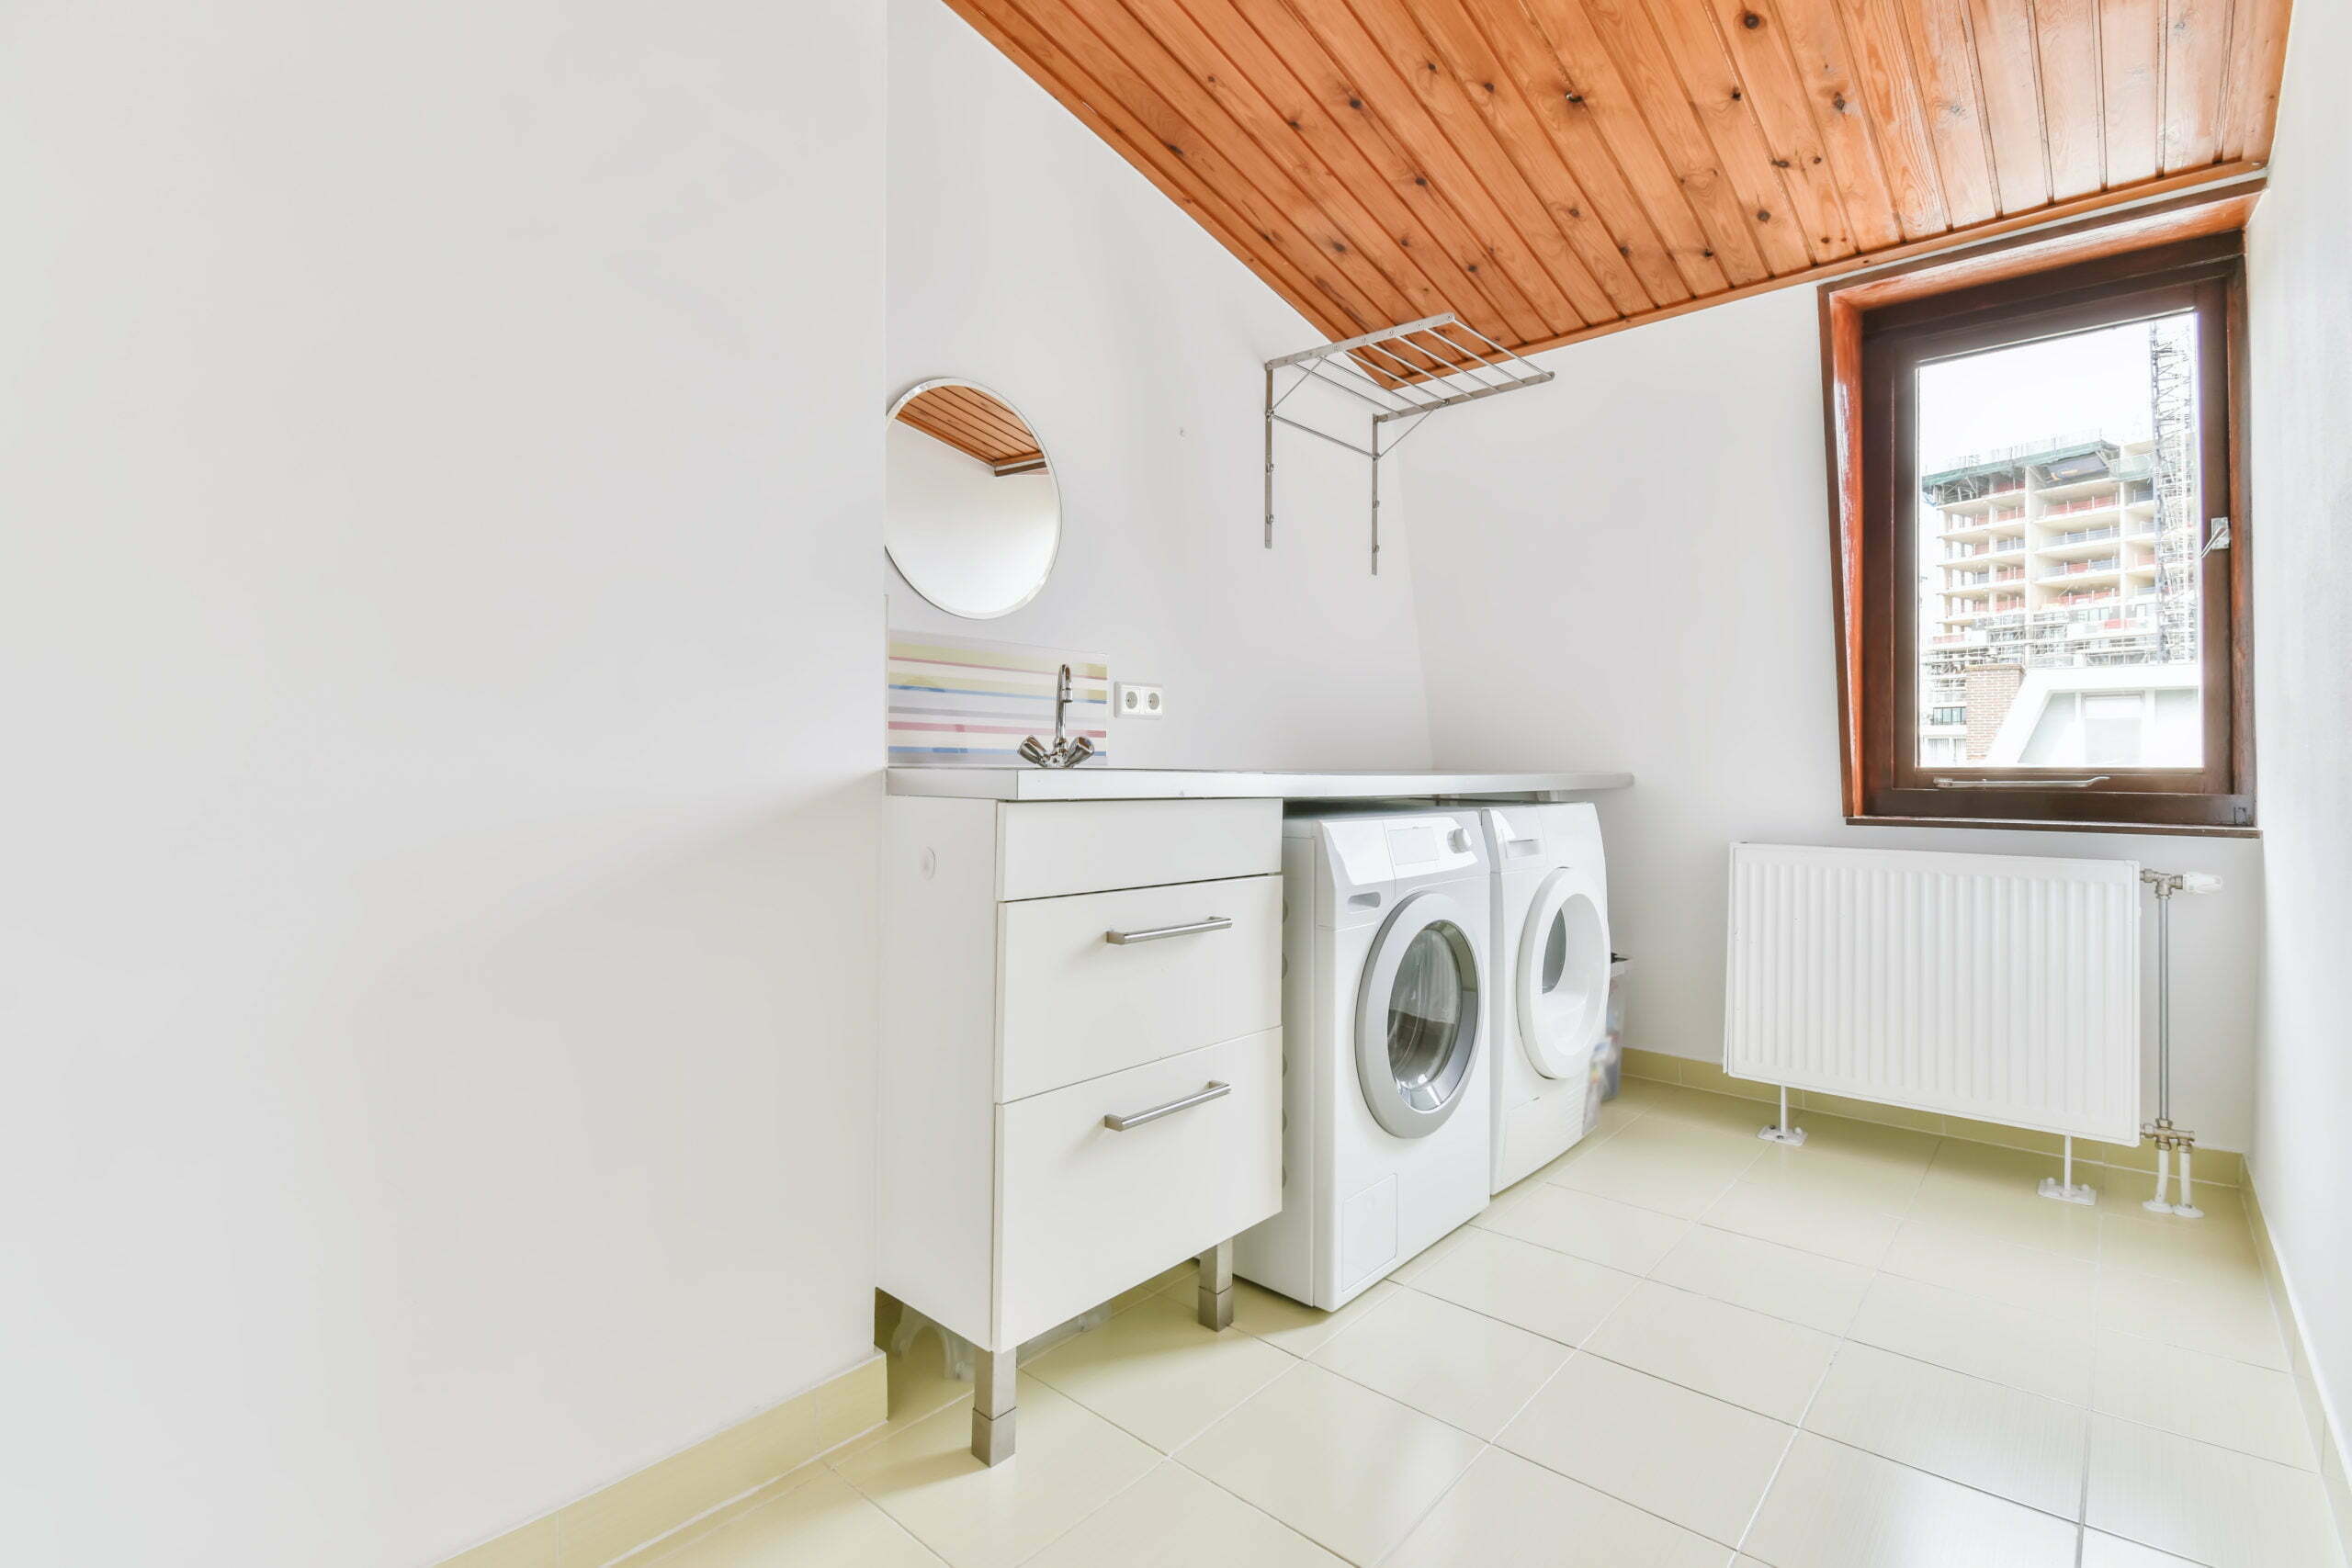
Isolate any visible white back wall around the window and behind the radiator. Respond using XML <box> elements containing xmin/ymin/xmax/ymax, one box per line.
<box><xmin>1404</xmin><ymin>289</ymin><xmax>2267</xmax><ymax>1149</ymax></box>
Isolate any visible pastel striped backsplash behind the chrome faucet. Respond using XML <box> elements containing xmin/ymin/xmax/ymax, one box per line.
<box><xmin>885</xmin><ymin>632</ymin><xmax>1110</xmax><ymax>769</ymax></box>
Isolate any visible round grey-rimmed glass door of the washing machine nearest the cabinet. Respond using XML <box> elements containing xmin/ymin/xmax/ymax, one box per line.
<box><xmin>1355</xmin><ymin>888</ymin><xmax>1479</xmax><ymax>1138</ymax></box>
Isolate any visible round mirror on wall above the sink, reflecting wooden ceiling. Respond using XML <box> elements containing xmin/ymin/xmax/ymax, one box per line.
<box><xmin>882</xmin><ymin>381</ymin><xmax>1061</xmax><ymax>621</ymax></box>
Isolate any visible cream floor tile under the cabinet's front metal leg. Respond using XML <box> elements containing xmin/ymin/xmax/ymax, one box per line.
<box><xmin>837</xmin><ymin>1378</ymin><xmax>1159</xmax><ymax>1568</ymax></box>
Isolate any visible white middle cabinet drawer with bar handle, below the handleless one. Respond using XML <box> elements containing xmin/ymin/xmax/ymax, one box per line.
<box><xmin>997</xmin><ymin>877</ymin><xmax>1282</xmax><ymax>1100</ymax></box>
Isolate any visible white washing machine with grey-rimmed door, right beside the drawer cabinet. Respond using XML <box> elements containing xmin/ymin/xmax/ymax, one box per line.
<box><xmin>1232</xmin><ymin>808</ymin><xmax>1494</xmax><ymax>1309</ymax></box>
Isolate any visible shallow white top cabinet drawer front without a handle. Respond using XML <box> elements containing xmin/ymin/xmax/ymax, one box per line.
<box><xmin>997</xmin><ymin>799</ymin><xmax>1282</xmax><ymax>898</ymax></box>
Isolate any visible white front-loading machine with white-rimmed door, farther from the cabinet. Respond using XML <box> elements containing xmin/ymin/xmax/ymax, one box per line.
<box><xmin>1479</xmin><ymin>804</ymin><xmax>1609</xmax><ymax>1192</ymax></box>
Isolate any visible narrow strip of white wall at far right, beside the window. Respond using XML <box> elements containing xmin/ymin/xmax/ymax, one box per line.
<box><xmin>2248</xmin><ymin>5</ymin><xmax>2352</xmax><ymax>1476</ymax></box>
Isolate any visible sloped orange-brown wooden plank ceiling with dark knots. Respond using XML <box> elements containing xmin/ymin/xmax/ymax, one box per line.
<box><xmin>948</xmin><ymin>0</ymin><xmax>2289</xmax><ymax>350</ymax></box>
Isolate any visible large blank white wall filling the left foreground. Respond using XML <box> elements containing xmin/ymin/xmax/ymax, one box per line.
<box><xmin>0</xmin><ymin>0</ymin><xmax>885</xmax><ymax>1568</ymax></box>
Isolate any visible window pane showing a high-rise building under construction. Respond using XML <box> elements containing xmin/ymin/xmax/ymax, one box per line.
<box><xmin>1915</xmin><ymin>310</ymin><xmax>2204</xmax><ymax>769</ymax></box>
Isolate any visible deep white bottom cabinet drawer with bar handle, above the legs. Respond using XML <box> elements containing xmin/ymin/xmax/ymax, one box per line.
<box><xmin>997</xmin><ymin>1030</ymin><xmax>1282</xmax><ymax>1347</ymax></box>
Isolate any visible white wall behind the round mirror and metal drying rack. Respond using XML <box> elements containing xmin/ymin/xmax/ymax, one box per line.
<box><xmin>873</xmin><ymin>0</ymin><xmax>1428</xmax><ymax>766</ymax></box>
